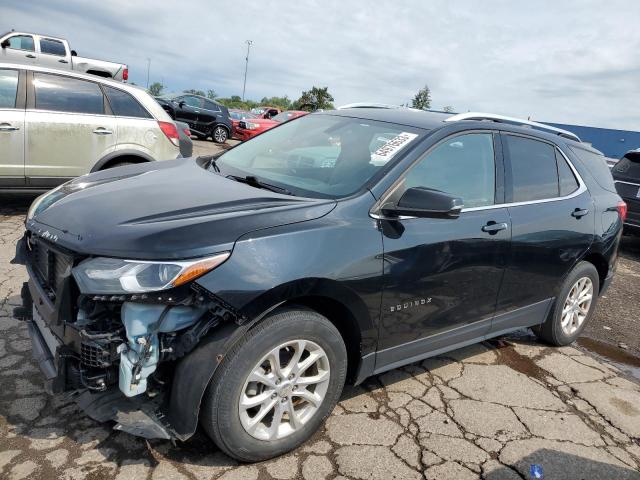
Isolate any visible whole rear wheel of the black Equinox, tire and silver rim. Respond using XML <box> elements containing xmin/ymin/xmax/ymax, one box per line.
<box><xmin>533</xmin><ymin>262</ymin><xmax>600</xmax><ymax>346</ymax></box>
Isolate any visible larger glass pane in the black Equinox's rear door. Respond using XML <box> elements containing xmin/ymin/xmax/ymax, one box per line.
<box><xmin>503</xmin><ymin>135</ymin><xmax>558</xmax><ymax>202</ymax></box>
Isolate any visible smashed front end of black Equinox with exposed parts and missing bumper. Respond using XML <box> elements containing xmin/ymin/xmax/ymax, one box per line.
<box><xmin>14</xmin><ymin>232</ymin><xmax>242</xmax><ymax>440</ymax></box>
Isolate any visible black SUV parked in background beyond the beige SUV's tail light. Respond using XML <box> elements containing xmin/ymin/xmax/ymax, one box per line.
<box><xmin>156</xmin><ymin>93</ymin><xmax>232</xmax><ymax>143</ymax></box>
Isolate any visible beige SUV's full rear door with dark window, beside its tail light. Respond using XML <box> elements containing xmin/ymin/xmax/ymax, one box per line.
<box><xmin>25</xmin><ymin>72</ymin><xmax>117</xmax><ymax>187</ymax></box>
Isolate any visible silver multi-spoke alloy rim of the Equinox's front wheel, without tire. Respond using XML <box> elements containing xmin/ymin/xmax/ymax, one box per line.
<box><xmin>238</xmin><ymin>340</ymin><xmax>330</xmax><ymax>440</ymax></box>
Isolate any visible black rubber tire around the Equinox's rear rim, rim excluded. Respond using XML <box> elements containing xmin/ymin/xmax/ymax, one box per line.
<box><xmin>532</xmin><ymin>262</ymin><xmax>600</xmax><ymax>347</ymax></box>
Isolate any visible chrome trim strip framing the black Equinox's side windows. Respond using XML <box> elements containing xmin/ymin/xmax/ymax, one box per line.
<box><xmin>369</xmin><ymin>130</ymin><xmax>588</xmax><ymax>220</ymax></box>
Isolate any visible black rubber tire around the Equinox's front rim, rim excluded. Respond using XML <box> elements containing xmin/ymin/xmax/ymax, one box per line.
<box><xmin>200</xmin><ymin>307</ymin><xmax>347</xmax><ymax>462</ymax></box>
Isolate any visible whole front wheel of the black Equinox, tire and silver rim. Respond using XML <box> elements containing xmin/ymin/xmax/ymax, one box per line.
<box><xmin>201</xmin><ymin>308</ymin><xmax>347</xmax><ymax>462</ymax></box>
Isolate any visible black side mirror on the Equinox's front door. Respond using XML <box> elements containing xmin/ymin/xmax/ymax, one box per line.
<box><xmin>382</xmin><ymin>187</ymin><xmax>463</xmax><ymax>218</ymax></box>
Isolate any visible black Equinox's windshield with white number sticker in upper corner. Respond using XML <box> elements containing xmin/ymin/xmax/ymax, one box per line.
<box><xmin>217</xmin><ymin>114</ymin><xmax>424</xmax><ymax>198</ymax></box>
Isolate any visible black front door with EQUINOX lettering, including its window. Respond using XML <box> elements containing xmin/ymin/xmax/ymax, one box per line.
<box><xmin>376</xmin><ymin>132</ymin><xmax>511</xmax><ymax>371</ymax></box>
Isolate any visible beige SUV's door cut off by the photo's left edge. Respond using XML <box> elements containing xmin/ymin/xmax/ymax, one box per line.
<box><xmin>0</xmin><ymin>68</ymin><xmax>25</xmax><ymax>188</ymax></box>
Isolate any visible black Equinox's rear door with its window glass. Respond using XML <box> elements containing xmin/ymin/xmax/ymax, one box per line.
<box><xmin>492</xmin><ymin>133</ymin><xmax>595</xmax><ymax>332</ymax></box>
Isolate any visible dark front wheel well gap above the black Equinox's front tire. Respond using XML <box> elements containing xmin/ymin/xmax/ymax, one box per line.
<box><xmin>283</xmin><ymin>296</ymin><xmax>361</xmax><ymax>382</ymax></box>
